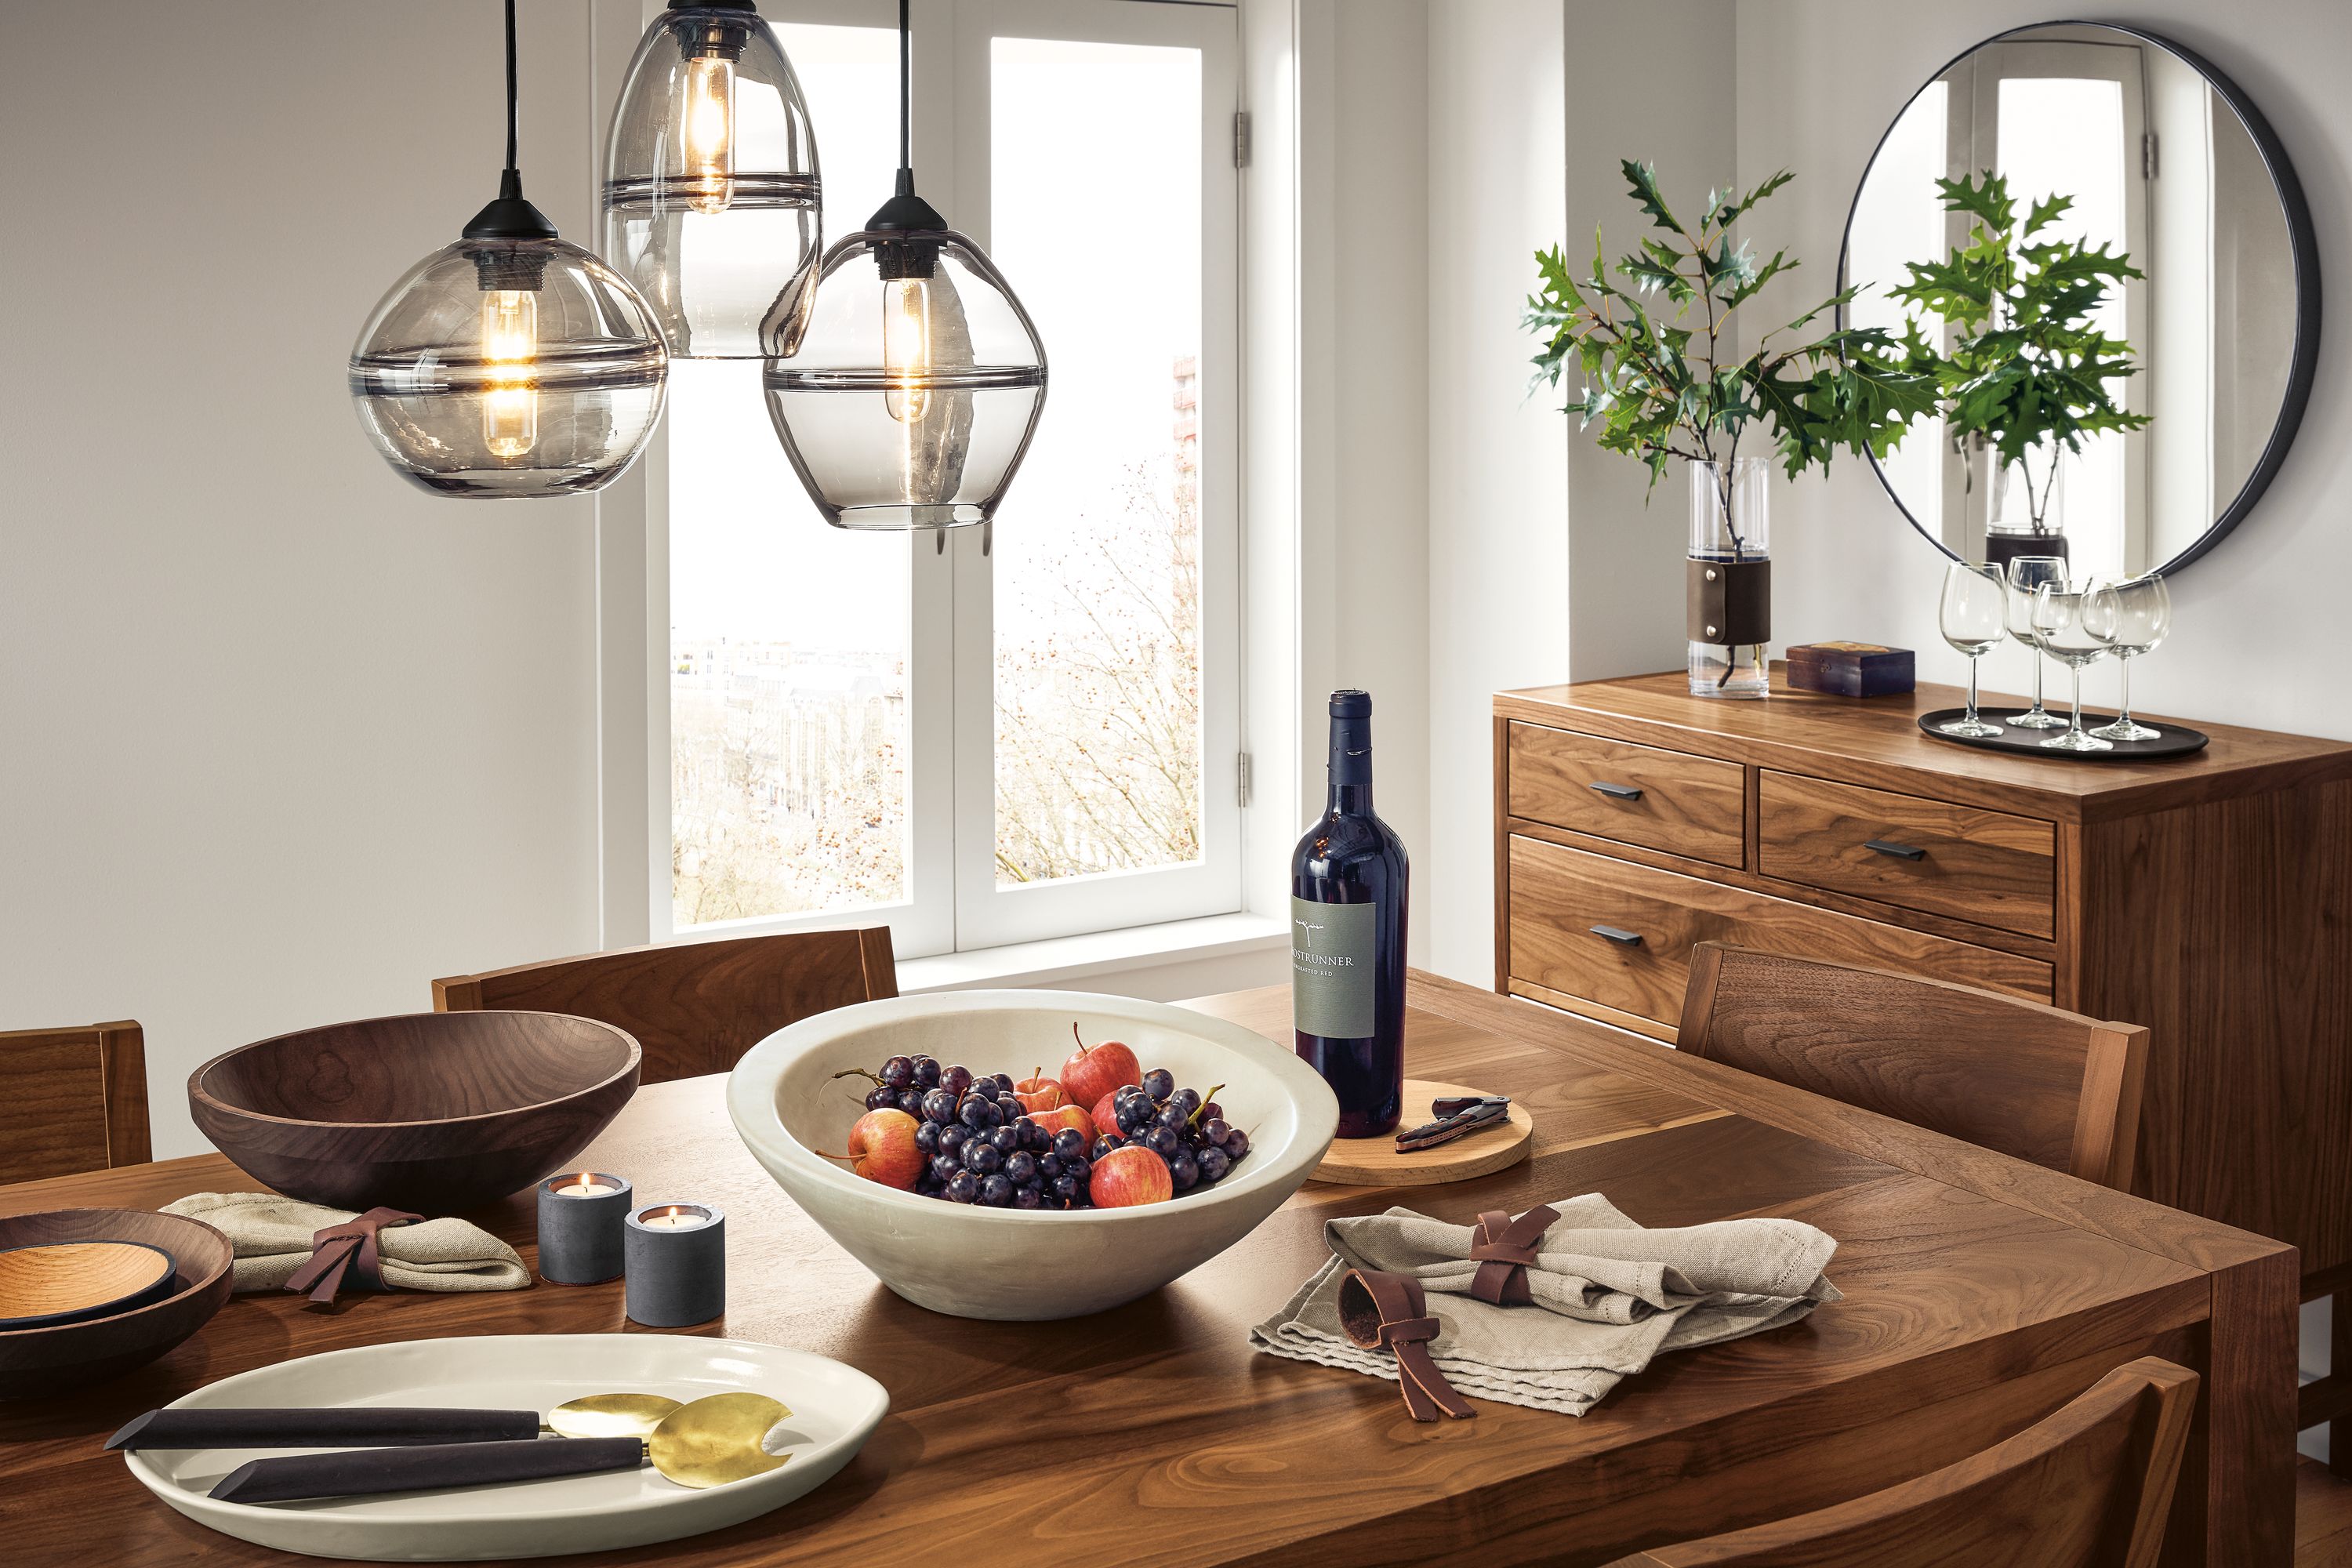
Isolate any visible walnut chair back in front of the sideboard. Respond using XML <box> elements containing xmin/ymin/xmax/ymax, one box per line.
<box><xmin>1679</xmin><ymin>942</ymin><xmax>2147</xmax><ymax>1192</ymax></box>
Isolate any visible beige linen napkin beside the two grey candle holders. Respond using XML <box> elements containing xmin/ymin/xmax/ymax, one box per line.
<box><xmin>162</xmin><ymin>1192</ymin><xmax>532</xmax><ymax>1293</ymax></box>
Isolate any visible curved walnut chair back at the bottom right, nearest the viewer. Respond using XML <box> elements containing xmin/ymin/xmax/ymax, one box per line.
<box><xmin>1616</xmin><ymin>1356</ymin><xmax>2197</xmax><ymax>1568</ymax></box>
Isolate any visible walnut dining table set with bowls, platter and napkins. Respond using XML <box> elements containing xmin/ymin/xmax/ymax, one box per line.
<box><xmin>0</xmin><ymin>975</ymin><xmax>2298</xmax><ymax>1568</ymax></box>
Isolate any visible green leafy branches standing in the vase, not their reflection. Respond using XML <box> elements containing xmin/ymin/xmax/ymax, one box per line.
<box><xmin>1524</xmin><ymin>158</ymin><xmax>1936</xmax><ymax>560</ymax></box>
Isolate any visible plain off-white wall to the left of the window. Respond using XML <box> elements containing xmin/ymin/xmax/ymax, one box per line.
<box><xmin>0</xmin><ymin>0</ymin><xmax>602</xmax><ymax>1154</ymax></box>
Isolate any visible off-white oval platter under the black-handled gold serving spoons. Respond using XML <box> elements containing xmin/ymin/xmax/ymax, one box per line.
<box><xmin>125</xmin><ymin>1333</ymin><xmax>889</xmax><ymax>1563</ymax></box>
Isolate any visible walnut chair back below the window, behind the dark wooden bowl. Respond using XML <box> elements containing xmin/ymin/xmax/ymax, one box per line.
<box><xmin>433</xmin><ymin>926</ymin><xmax>898</xmax><ymax>1083</ymax></box>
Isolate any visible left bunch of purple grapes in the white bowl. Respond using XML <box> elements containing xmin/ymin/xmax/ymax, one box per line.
<box><xmin>866</xmin><ymin>1055</ymin><xmax>1094</xmax><ymax>1208</ymax></box>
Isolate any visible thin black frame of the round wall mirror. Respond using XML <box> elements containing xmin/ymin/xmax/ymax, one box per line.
<box><xmin>1837</xmin><ymin>21</ymin><xmax>2319</xmax><ymax>576</ymax></box>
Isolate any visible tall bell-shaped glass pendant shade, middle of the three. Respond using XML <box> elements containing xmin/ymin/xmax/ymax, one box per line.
<box><xmin>604</xmin><ymin>0</ymin><xmax>823</xmax><ymax>360</ymax></box>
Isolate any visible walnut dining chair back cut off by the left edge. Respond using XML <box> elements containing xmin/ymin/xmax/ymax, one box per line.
<box><xmin>0</xmin><ymin>1022</ymin><xmax>155</xmax><ymax>1182</ymax></box>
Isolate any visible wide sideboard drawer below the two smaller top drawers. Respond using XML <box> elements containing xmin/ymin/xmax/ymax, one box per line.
<box><xmin>1508</xmin><ymin>834</ymin><xmax>2051</xmax><ymax>1025</ymax></box>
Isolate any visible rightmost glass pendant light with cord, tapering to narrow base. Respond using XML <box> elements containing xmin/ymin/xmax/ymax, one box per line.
<box><xmin>762</xmin><ymin>0</ymin><xmax>1044</xmax><ymax>529</ymax></box>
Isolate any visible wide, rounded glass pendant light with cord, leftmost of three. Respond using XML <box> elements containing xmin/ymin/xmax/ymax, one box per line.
<box><xmin>350</xmin><ymin>0</ymin><xmax>670</xmax><ymax>499</ymax></box>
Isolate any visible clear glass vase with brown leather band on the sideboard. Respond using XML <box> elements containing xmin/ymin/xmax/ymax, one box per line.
<box><xmin>1686</xmin><ymin>459</ymin><xmax>1771</xmax><ymax>696</ymax></box>
